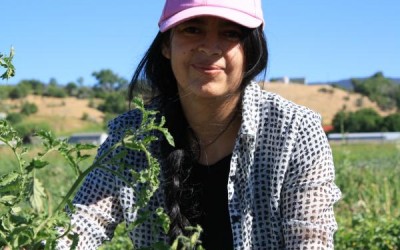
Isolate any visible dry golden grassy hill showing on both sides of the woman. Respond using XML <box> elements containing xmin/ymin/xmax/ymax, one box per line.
<box><xmin>1</xmin><ymin>83</ymin><xmax>394</xmax><ymax>134</ymax></box>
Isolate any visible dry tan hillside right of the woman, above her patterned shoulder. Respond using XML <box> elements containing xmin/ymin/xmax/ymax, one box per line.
<box><xmin>262</xmin><ymin>82</ymin><xmax>394</xmax><ymax>125</ymax></box>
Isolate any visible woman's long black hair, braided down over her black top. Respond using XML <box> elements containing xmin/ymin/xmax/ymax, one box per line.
<box><xmin>128</xmin><ymin>26</ymin><xmax>268</xmax><ymax>241</ymax></box>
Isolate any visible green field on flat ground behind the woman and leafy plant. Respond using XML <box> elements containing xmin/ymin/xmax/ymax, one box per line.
<box><xmin>0</xmin><ymin>143</ymin><xmax>400</xmax><ymax>249</ymax></box>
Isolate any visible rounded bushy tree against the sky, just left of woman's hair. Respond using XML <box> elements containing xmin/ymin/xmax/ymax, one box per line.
<box><xmin>92</xmin><ymin>69</ymin><xmax>128</xmax><ymax>91</ymax></box>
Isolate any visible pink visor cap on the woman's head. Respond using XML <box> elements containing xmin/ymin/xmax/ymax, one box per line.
<box><xmin>158</xmin><ymin>0</ymin><xmax>264</xmax><ymax>32</ymax></box>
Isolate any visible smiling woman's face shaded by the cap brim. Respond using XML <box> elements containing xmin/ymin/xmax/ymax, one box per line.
<box><xmin>162</xmin><ymin>16</ymin><xmax>245</xmax><ymax>98</ymax></box>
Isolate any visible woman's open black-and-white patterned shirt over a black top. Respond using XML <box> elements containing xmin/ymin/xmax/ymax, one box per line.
<box><xmin>58</xmin><ymin>83</ymin><xmax>341</xmax><ymax>249</ymax></box>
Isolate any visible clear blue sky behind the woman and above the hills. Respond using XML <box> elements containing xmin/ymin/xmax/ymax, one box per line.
<box><xmin>0</xmin><ymin>0</ymin><xmax>400</xmax><ymax>85</ymax></box>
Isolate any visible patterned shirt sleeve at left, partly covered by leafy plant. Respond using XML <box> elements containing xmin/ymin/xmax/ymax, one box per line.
<box><xmin>57</xmin><ymin>126</ymin><xmax>123</xmax><ymax>249</ymax></box>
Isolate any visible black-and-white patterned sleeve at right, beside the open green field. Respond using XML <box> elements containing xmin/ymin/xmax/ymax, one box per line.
<box><xmin>281</xmin><ymin>114</ymin><xmax>341</xmax><ymax>249</ymax></box>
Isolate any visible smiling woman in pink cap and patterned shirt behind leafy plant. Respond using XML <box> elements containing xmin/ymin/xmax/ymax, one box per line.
<box><xmin>60</xmin><ymin>0</ymin><xmax>340</xmax><ymax>249</ymax></box>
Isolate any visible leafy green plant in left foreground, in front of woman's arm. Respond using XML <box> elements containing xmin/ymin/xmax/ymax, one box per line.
<box><xmin>0</xmin><ymin>99</ymin><xmax>202</xmax><ymax>250</ymax></box>
